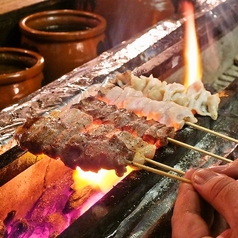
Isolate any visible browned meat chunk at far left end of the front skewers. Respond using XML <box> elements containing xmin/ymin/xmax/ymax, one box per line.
<box><xmin>15</xmin><ymin>109</ymin><xmax>93</xmax><ymax>157</ymax></box>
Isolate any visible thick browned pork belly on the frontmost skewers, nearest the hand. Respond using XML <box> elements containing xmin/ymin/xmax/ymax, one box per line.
<box><xmin>15</xmin><ymin>105</ymin><xmax>156</xmax><ymax>176</ymax></box>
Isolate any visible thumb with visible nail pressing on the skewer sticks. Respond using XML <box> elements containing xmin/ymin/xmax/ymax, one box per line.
<box><xmin>191</xmin><ymin>169</ymin><xmax>238</xmax><ymax>227</ymax></box>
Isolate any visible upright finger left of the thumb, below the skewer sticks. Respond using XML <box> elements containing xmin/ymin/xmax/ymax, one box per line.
<box><xmin>172</xmin><ymin>171</ymin><xmax>209</xmax><ymax>238</ymax></box>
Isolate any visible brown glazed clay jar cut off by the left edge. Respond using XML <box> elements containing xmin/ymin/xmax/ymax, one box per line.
<box><xmin>0</xmin><ymin>47</ymin><xmax>44</xmax><ymax>110</ymax></box>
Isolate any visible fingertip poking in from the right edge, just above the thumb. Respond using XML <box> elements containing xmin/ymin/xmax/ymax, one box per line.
<box><xmin>209</xmin><ymin>159</ymin><xmax>238</xmax><ymax>179</ymax></box>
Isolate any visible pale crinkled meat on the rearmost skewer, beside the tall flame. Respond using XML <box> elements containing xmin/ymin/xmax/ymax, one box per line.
<box><xmin>113</xmin><ymin>71</ymin><xmax>220</xmax><ymax>120</ymax></box>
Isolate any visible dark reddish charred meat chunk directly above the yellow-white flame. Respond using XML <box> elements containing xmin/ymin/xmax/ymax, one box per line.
<box><xmin>58</xmin><ymin>133</ymin><xmax>135</xmax><ymax>176</ymax></box>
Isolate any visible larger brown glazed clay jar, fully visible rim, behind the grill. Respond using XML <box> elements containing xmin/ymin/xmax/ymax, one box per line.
<box><xmin>19</xmin><ymin>10</ymin><xmax>106</xmax><ymax>84</ymax></box>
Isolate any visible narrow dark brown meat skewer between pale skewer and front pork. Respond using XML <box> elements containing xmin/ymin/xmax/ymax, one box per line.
<box><xmin>72</xmin><ymin>97</ymin><xmax>174</xmax><ymax>147</ymax></box>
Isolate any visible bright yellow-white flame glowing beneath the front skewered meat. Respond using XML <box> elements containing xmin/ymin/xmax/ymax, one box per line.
<box><xmin>73</xmin><ymin>166</ymin><xmax>133</xmax><ymax>214</ymax></box>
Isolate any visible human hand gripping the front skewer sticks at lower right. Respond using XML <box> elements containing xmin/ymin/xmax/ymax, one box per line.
<box><xmin>172</xmin><ymin>160</ymin><xmax>238</xmax><ymax>238</ymax></box>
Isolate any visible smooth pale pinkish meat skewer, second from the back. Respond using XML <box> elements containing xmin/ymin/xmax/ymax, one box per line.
<box><xmin>98</xmin><ymin>86</ymin><xmax>197</xmax><ymax>130</ymax></box>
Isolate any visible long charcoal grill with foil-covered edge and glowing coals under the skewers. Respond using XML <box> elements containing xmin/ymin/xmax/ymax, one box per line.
<box><xmin>0</xmin><ymin>0</ymin><xmax>238</xmax><ymax>238</ymax></box>
